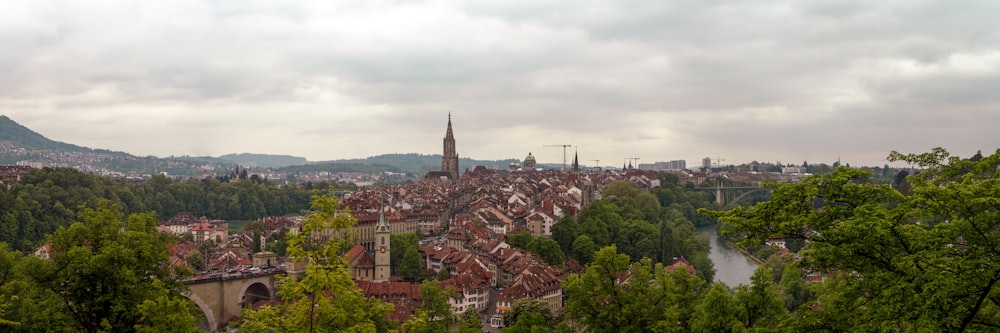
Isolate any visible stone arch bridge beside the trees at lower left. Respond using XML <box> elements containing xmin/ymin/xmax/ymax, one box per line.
<box><xmin>184</xmin><ymin>268</ymin><xmax>285</xmax><ymax>332</ymax></box>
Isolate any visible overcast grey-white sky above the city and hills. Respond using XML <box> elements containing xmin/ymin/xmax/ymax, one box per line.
<box><xmin>0</xmin><ymin>0</ymin><xmax>1000</xmax><ymax>166</ymax></box>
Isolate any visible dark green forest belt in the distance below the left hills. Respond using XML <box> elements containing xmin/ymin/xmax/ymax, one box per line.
<box><xmin>0</xmin><ymin>168</ymin><xmax>352</xmax><ymax>251</ymax></box>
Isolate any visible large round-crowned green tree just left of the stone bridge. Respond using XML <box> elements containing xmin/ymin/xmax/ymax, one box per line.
<box><xmin>25</xmin><ymin>201</ymin><xmax>197</xmax><ymax>332</ymax></box>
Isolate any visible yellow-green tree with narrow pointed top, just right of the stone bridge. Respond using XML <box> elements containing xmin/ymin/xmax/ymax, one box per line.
<box><xmin>239</xmin><ymin>196</ymin><xmax>392</xmax><ymax>332</ymax></box>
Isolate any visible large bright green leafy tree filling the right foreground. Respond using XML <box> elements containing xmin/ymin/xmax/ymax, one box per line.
<box><xmin>709</xmin><ymin>148</ymin><xmax>1000</xmax><ymax>332</ymax></box>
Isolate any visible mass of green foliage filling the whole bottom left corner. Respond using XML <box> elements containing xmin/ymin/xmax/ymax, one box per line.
<box><xmin>0</xmin><ymin>201</ymin><xmax>199</xmax><ymax>332</ymax></box>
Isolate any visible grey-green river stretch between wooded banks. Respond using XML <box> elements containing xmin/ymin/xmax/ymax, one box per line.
<box><xmin>698</xmin><ymin>225</ymin><xmax>757</xmax><ymax>287</ymax></box>
